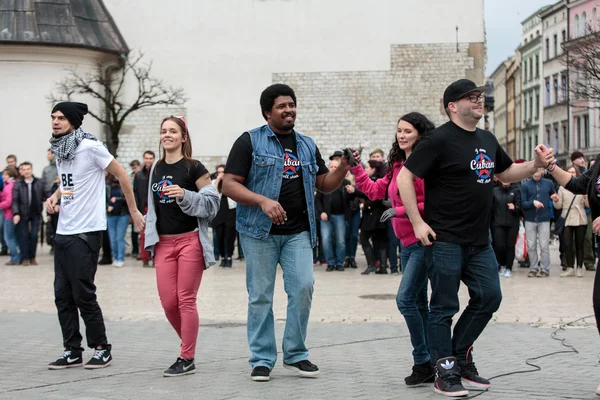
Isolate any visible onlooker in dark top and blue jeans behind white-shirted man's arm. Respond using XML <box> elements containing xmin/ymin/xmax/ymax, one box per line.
<box><xmin>106</xmin><ymin>174</ymin><xmax>130</xmax><ymax>268</ymax></box>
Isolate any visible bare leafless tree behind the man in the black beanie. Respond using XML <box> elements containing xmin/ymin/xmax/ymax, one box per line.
<box><xmin>48</xmin><ymin>52</ymin><xmax>187</xmax><ymax>155</ymax></box>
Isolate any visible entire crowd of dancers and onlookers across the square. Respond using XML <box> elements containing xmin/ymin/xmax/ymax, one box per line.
<box><xmin>0</xmin><ymin>79</ymin><xmax>600</xmax><ymax>397</ymax></box>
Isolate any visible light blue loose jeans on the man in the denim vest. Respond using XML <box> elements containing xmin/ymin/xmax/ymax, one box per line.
<box><xmin>240</xmin><ymin>232</ymin><xmax>315</xmax><ymax>369</ymax></box>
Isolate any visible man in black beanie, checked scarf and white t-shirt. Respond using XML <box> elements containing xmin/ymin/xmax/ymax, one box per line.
<box><xmin>46</xmin><ymin>102</ymin><xmax>145</xmax><ymax>369</ymax></box>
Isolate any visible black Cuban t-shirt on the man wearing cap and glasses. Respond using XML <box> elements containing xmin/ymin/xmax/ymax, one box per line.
<box><xmin>404</xmin><ymin>121</ymin><xmax>512</xmax><ymax>245</ymax></box>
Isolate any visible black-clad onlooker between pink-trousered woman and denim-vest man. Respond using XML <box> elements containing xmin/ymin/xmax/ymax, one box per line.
<box><xmin>211</xmin><ymin>164</ymin><xmax>237</xmax><ymax>268</ymax></box>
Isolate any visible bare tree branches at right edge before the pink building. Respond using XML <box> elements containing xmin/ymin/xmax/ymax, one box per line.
<box><xmin>562</xmin><ymin>24</ymin><xmax>600</xmax><ymax>108</ymax></box>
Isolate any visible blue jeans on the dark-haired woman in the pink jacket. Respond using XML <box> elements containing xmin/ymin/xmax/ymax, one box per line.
<box><xmin>396</xmin><ymin>242</ymin><xmax>431</xmax><ymax>364</ymax></box>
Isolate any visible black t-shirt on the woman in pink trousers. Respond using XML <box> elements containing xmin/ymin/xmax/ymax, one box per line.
<box><xmin>150</xmin><ymin>158</ymin><xmax>208</xmax><ymax>235</ymax></box>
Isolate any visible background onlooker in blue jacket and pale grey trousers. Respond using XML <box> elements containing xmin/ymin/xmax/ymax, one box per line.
<box><xmin>521</xmin><ymin>170</ymin><xmax>558</xmax><ymax>278</ymax></box>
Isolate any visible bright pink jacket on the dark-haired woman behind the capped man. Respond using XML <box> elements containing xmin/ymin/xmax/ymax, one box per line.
<box><xmin>352</xmin><ymin>162</ymin><xmax>425</xmax><ymax>247</ymax></box>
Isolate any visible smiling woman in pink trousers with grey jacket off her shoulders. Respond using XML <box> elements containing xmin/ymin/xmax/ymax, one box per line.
<box><xmin>145</xmin><ymin>116</ymin><xmax>219</xmax><ymax>376</ymax></box>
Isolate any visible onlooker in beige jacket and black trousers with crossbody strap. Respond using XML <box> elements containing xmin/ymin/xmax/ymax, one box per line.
<box><xmin>556</xmin><ymin>164</ymin><xmax>589</xmax><ymax>278</ymax></box>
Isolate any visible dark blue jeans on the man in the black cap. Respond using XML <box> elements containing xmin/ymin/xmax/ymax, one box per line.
<box><xmin>428</xmin><ymin>242</ymin><xmax>502</xmax><ymax>362</ymax></box>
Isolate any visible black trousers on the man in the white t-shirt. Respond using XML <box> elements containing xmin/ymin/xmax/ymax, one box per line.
<box><xmin>54</xmin><ymin>232</ymin><xmax>108</xmax><ymax>349</ymax></box>
